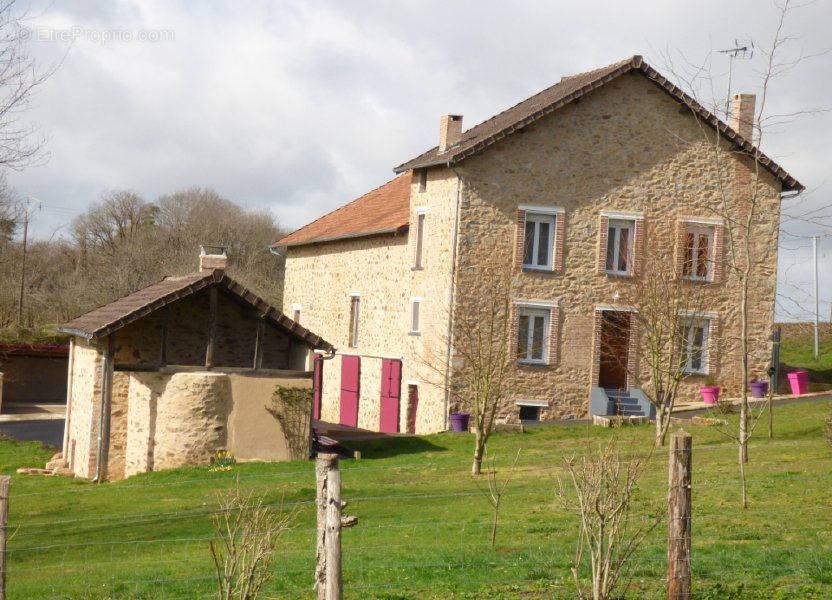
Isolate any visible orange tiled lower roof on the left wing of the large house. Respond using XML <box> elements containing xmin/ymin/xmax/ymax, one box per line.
<box><xmin>274</xmin><ymin>171</ymin><xmax>411</xmax><ymax>246</ymax></box>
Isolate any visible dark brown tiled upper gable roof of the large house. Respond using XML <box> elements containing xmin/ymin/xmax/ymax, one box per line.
<box><xmin>394</xmin><ymin>55</ymin><xmax>804</xmax><ymax>191</ymax></box>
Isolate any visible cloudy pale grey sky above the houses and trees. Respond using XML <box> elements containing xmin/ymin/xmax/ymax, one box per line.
<box><xmin>9</xmin><ymin>0</ymin><xmax>832</xmax><ymax>319</ymax></box>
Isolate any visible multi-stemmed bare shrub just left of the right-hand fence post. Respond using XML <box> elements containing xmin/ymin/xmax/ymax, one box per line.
<box><xmin>555</xmin><ymin>437</ymin><xmax>661</xmax><ymax>600</ymax></box>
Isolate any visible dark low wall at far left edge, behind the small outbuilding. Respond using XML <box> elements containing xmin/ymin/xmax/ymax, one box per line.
<box><xmin>0</xmin><ymin>354</ymin><xmax>68</xmax><ymax>404</ymax></box>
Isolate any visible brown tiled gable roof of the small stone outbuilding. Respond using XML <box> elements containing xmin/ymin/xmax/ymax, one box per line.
<box><xmin>58</xmin><ymin>269</ymin><xmax>334</xmax><ymax>350</ymax></box>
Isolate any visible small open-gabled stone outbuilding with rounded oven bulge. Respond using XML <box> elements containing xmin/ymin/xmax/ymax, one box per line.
<box><xmin>53</xmin><ymin>246</ymin><xmax>332</xmax><ymax>481</ymax></box>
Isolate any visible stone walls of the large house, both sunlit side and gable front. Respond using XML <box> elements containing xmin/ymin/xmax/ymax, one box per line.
<box><xmin>283</xmin><ymin>74</ymin><xmax>781</xmax><ymax>433</ymax></box>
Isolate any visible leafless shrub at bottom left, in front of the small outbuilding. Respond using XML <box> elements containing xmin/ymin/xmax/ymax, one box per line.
<box><xmin>209</xmin><ymin>481</ymin><xmax>296</xmax><ymax>600</ymax></box>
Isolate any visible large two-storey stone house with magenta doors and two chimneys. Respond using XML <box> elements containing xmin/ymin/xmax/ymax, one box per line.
<box><xmin>276</xmin><ymin>56</ymin><xmax>803</xmax><ymax>433</ymax></box>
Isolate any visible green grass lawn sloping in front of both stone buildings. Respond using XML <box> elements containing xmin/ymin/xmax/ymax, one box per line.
<box><xmin>0</xmin><ymin>402</ymin><xmax>832</xmax><ymax>600</ymax></box>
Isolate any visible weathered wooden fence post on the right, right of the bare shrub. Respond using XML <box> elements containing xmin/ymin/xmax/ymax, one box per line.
<box><xmin>667</xmin><ymin>431</ymin><xmax>693</xmax><ymax>600</ymax></box>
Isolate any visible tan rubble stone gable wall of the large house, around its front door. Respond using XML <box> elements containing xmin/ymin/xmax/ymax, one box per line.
<box><xmin>448</xmin><ymin>75</ymin><xmax>780</xmax><ymax>418</ymax></box>
